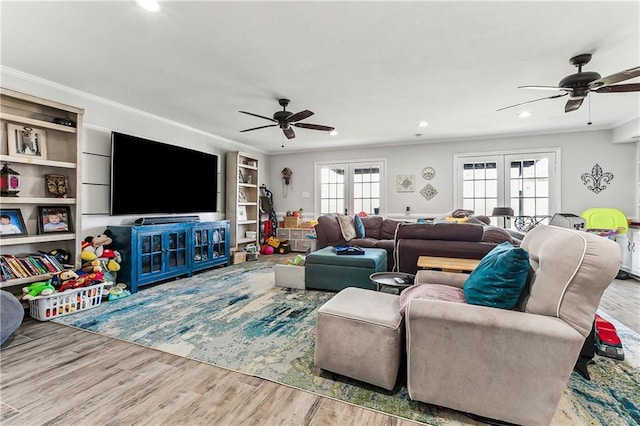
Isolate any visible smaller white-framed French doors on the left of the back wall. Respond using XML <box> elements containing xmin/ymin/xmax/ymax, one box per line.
<box><xmin>315</xmin><ymin>160</ymin><xmax>384</xmax><ymax>215</ymax></box>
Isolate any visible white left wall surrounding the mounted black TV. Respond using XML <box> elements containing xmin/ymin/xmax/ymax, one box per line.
<box><xmin>1</xmin><ymin>68</ymin><xmax>267</xmax><ymax>237</ymax></box>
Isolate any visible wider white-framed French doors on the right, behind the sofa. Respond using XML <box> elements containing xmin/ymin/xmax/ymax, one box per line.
<box><xmin>454</xmin><ymin>149</ymin><xmax>560</xmax><ymax>228</ymax></box>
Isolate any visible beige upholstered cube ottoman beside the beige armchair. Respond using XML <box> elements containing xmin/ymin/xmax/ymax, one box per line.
<box><xmin>314</xmin><ymin>287</ymin><xmax>404</xmax><ymax>390</ymax></box>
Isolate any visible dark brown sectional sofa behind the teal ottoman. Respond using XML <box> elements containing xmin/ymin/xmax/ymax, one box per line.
<box><xmin>315</xmin><ymin>214</ymin><xmax>519</xmax><ymax>274</ymax></box>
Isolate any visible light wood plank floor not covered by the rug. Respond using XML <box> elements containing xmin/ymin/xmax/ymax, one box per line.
<box><xmin>0</xmin><ymin>257</ymin><xmax>640</xmax><ymax>426</ymax></box>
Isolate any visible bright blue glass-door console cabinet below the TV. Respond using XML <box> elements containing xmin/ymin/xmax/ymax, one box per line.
<box><xmin>107</xmin><ymin>220</ymin><xmax>230</xmax><ymax>293</ymax></box>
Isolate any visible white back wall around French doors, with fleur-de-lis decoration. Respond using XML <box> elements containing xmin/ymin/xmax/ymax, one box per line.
<box><xmin>267</xmin><ymin>131</ymin><xmax>636</xmax><ymax>217</ymax></box>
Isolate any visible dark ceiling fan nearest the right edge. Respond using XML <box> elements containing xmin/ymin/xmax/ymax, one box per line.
<box><xmin>498</xmin><ymin>53</ymin><xmax>640</xmax><ymax>112</ymax></box>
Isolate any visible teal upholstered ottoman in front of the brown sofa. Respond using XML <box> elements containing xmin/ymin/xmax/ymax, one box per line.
<box><xmin>304</xmin><ymin>246</ymin><xmax>387</xmax><ymax>291</ymax></box>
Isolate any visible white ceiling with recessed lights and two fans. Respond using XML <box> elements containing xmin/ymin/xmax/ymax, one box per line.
<box><xmin>1</xmin><ymin>0</ymin><xmax>640</xmax><ymax>153</ymax></box>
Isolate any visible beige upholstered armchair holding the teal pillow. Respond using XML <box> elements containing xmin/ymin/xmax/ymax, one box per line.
<box><xmin>405</xmin><ymin>225</ymin><xmax>620</xmax><ymax>425</ymax></box>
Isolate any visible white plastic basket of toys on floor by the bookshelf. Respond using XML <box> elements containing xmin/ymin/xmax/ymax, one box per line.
<box><xmin>29</xmin><ymin>283</ymin><xmax>104</xmax><ymax>321</ymax></box>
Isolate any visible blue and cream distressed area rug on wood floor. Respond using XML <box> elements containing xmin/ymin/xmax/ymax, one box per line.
<box><xmin>54</xmin><ymin>262</ymin><xmax>640</xmax><ymax>425</ymax></box>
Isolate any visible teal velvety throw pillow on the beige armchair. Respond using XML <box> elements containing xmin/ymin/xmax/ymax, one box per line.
<box><xmin>463</xmin><ymin>242</ymin><xmax>529</xmax><ymax>309</ymax></box>
